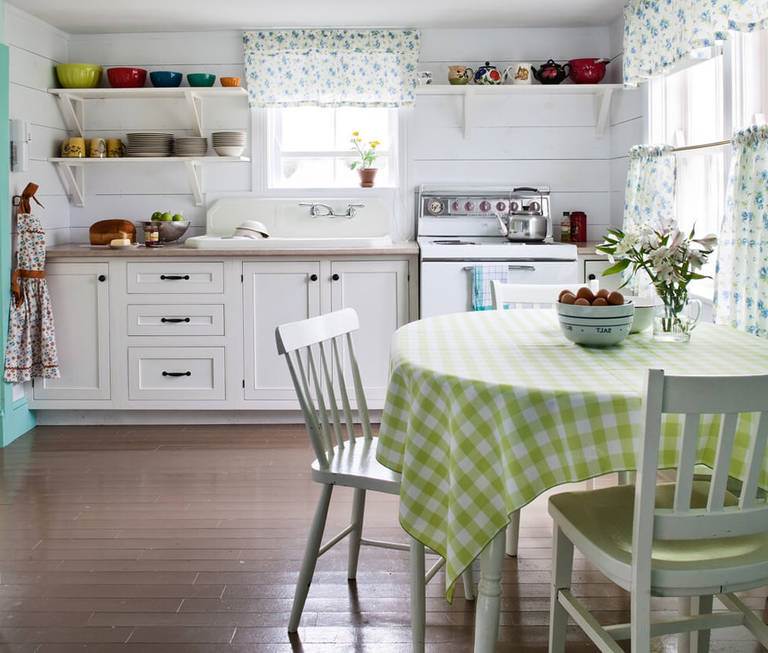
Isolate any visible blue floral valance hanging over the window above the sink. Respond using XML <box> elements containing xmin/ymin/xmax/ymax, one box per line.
<box><xmin>243</xmin><ymin>29</ymin><xmax>419</xmax><ymax>108</ymax></box>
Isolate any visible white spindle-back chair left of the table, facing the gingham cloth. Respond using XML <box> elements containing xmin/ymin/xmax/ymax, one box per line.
<box><xmin>275</xmin><ymin>308</ymin><xmax>474</xmax><ymax>651</ymax></box>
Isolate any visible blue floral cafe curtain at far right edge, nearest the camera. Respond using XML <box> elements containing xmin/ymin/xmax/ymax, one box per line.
<box><xmin>715</xmin><ymin>126</ymin><xmax>768</xmax><ymax>337</ymax></box>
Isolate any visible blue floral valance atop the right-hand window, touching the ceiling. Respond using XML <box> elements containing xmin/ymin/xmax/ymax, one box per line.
<box><xmin>624</xmin><ymin>0</ymin><xmax>768</xmax><ymax>86</ymax></box>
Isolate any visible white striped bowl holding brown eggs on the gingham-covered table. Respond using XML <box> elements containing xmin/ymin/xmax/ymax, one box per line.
<box><xmin>557</xmin><ymin>302</ymin><xmax>635</xmax><ymax>347</ymax></box>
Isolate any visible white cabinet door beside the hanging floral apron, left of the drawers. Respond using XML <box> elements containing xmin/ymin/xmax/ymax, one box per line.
<box><xmin>33</xmin><ymin>262</ymin><xmax>110</xmax><ymax>401</ymax></box>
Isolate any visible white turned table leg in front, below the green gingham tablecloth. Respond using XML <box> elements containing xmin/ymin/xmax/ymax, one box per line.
<box><xmin>474</xmin><ymin>530</ymin><xmax>506</xmax><ymax>653</ymax></box>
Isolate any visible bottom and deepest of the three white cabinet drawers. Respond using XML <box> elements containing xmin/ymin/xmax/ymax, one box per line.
<box><xmin>128</xmin><ymin>347</ymin><xmax>225</xmax><ymax>401</ymax></box>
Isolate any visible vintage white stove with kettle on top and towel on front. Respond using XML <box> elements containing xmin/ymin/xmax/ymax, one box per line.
<box><xmin>417</xmin><ymin>186</ymin><xmax>578</xmax><ymax>317</ymax></box>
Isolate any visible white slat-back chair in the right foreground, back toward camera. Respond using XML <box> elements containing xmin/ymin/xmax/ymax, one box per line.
<box><xmin>549</xmin><ymin>370</ymin><xmax>768</xmax><ymax>653</ymax></box>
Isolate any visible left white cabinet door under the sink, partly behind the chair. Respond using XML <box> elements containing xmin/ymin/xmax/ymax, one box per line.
<box><xmin>243</xmin><ymin>261</ymin><xmax>320</xmax><ymax>405</ymax></box>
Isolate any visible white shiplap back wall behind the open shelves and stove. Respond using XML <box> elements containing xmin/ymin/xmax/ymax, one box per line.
<box><xmin>15</xmin><ymin>22</ymin><xmax>641</xmax><ymax>241</ymax></box>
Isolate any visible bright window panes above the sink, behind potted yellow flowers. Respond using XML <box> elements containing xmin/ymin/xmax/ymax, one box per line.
<box><xmin>268</xmin><ymin>107</ymin><xmax>397</xmax><ymax>189</ymax></box>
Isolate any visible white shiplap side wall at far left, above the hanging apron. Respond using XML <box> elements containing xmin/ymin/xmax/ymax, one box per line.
<box><xmin>5</xmin><ymin>5</ymin><xmax>69</xmax><ymax>244</ymax></box>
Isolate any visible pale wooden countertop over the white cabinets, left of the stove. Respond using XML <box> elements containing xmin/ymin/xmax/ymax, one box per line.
<box><xmin>46</xmin><ymin>241</ymin><xmax>419</xmax><ymax>260</ymax></box>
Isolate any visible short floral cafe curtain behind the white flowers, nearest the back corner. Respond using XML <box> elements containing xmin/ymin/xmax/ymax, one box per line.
<box><xmin>624</xmin><ymin>145</ymin><xmax>677</xmax><ymax>230</ymax></box>
